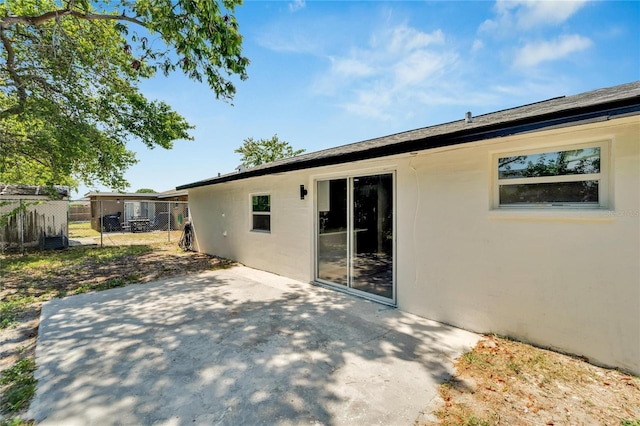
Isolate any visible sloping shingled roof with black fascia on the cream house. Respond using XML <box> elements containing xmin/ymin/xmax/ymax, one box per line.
<box><xmin>176</xmin><ymin>81</ymin><xmax>640</xmax><ymax>190</ymax></box>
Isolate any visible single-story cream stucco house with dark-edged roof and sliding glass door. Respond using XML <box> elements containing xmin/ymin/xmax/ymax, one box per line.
<box><xmin>177</xmin><ymin>82</ymin><xmax>640</xmax><ymax>374</ymax></box>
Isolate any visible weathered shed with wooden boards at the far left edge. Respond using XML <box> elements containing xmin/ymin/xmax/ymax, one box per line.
<box><xmin>0</xmin><ymin>184</ymin><xmax>69</xmax><ymax>247</ymax></box>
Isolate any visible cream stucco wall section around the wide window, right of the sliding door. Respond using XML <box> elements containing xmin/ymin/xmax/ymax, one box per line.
<box><xmin>397</xmin><ymin>117</ymin><xmax>640</xmax><ymax>373</ymax></box>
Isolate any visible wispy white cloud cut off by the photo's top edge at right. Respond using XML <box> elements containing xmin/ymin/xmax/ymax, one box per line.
<box><xmin>479</xmin><ymin>0</ymin><xmax>587</xmax><ymax>35</ymax></box>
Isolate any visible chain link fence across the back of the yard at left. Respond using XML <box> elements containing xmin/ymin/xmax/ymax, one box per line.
<box><xmin>0</xmin><ymin>198</ymin><xmax>189</xmax><ymax>251</ymax></box>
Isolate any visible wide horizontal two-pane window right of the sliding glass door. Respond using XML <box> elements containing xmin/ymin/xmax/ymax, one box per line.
<box><xmin>493</xmin><ymin>142</ymin><xmax>608</xmax><ymax>208</ymax></box>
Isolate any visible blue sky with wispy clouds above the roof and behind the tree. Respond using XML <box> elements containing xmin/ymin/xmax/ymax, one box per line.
<box><xmin>78</xmin><ymin>0</ymin><xmax>640</xmax><ymax>196</ymax></box>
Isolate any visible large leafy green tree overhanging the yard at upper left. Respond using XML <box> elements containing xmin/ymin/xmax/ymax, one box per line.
<box><xmin>0</xmin><ymin>0</ymin><xmax>249</xmax><ymax>190</ymax></box>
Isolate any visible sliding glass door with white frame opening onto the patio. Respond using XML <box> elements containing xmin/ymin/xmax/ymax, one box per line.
<box><xmin>317</xmin><ymin>174</ymin><xmax>395</xmax><ymax>301</ymax></box>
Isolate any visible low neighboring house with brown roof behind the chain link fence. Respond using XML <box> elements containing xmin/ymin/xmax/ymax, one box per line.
<box><xmin>85</xmin><ymin>190</ymin><xmax>188</xmax><ymax>231</ymax></box>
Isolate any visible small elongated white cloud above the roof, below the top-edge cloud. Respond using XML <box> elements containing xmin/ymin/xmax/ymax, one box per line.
<box><xmin>514</xmin><ymin>34</ymin><xmax>593</xmax><ymax>67</ymax></box>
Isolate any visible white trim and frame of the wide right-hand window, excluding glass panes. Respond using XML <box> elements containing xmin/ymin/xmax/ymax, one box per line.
<box><xmin>491</xmin><ymin>139</ymin><xmax>611</xmax><ymax>210</ymax></box>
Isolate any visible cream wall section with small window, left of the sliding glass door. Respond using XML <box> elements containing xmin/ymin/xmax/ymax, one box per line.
<box><xmin>189</xmin><ymin>172</ymin><xmax>313</xmax><ymax>281</ymax></box>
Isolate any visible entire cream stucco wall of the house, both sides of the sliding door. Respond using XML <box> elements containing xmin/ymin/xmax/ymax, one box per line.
<box><xmin>189</xmin><ymin>117</ymin><xmax>640</xmax><ymax>374</ymax></box>
